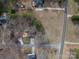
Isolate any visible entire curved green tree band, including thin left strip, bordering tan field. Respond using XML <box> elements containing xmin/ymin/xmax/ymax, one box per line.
<box><xmin>10</xmin><ymin>13</ymin><xmax>44</xmax><ymax>33</ymax></box>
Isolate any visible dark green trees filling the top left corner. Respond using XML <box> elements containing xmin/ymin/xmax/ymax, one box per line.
<box><xmin>0</xmin><ymin>0</ymin><xmax>17</xmax><ymax>14</ymax></box>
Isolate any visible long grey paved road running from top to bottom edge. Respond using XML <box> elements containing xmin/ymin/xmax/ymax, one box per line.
<box><xmin>59</xmin><ymin>0</ymin><xmax>67</xmax><ymax>59</ymax></box>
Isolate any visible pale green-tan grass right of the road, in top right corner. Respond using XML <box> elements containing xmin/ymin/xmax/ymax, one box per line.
<box><xmin>68</xmin><ymin>0</ymin><xmax>79</xmax><ymax>14</ymax></box>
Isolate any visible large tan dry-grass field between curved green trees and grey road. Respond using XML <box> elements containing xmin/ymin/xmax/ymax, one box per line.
<box><xmin>35</xmin><ymin>10</ymin><xmax>64</xmax><ymax>44</ymax></box>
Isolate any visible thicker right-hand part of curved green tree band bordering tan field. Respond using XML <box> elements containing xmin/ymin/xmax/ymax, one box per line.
<box><xmin>23</xmin><ymin>13</ymin><xmax>44</xmax><ymax>32</ymax></box>
